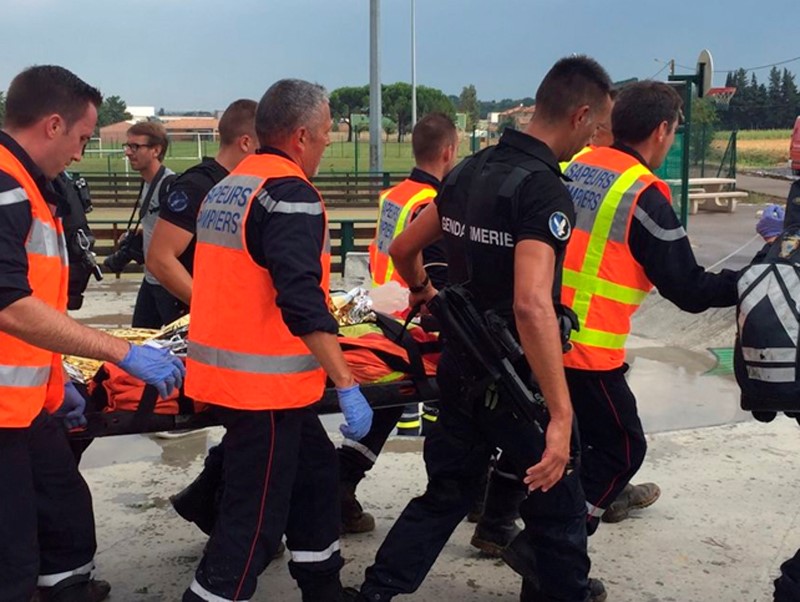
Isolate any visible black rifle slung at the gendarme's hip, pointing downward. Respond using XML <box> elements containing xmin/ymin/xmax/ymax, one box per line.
<box><xmin>427</xmin><ymin>285</ymin><xmax>580</xmax><ymax>470</ymax></box>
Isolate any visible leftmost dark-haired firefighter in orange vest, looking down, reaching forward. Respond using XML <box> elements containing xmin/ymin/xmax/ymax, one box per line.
<box><xmin>0</xmin><ymin>66</ymin><xmax>183</xmax><ymax>602</ymax></box>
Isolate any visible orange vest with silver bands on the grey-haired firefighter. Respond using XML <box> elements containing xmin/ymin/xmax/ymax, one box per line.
<box><xmin>186</xmin><ymin>154</ymin><xmax>330</xmax><ymax>410</ymax></box>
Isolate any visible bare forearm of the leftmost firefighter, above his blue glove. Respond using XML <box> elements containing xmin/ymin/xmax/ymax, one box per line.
<box><xmin>0</xmin><ymin>297</ymin><xmax>130</xmax><ymax>364</ymax></box>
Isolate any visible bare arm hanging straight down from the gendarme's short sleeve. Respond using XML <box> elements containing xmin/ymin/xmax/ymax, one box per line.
<box><xmin>514</xmin><ymin>240</ymin><xmax>572</xmax><ymax>491</ymax></box>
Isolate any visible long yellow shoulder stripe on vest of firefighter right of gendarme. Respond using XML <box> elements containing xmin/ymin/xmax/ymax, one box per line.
<box><xmin>564</xmin><ymin>164</ymin><xmax>651</xmax><ymax>348</ymax></box>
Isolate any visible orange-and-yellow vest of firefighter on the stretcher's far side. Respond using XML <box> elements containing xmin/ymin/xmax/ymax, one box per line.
<box><xmin>369</xmin><ymin>178</ymin><xmax>436</xmax><ymax>287</ymax></box>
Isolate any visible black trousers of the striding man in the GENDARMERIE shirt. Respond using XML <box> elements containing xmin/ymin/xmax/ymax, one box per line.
<box><xmin>361</xmin><ymin>353</ymin><xmax>590</xmax><ymax>602</ymax></box>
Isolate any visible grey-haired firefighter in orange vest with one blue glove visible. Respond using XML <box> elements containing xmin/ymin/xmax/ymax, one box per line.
<box><xmin>183</xmin><ymin>80</ymin><xmax>372</xmax><ymax>602</ymax></box>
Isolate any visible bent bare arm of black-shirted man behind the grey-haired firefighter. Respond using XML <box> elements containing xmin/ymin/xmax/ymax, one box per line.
<box><xmin>145</xmin><ymin>218</ymin><xmax>192</xmax><ymax>305</ymax></box>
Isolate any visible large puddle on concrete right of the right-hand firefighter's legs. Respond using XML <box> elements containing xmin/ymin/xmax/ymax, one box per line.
<box><xmin>627</xmin><ymin>347</ymin><xmax>751</xmax><ymax>433</ymax></box>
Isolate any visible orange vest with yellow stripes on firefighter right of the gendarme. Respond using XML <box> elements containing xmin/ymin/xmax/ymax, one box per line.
<box><xmin>561</xmin><ymin>147</ymin><xmax>671</xmax><ymax>370</ymax></box>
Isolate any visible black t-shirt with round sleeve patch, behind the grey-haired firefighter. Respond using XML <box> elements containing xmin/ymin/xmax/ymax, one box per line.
<box><xmin>158</xmin><ymin>157</ymin><xmax>228</xmax><ymax>274</ymax></box>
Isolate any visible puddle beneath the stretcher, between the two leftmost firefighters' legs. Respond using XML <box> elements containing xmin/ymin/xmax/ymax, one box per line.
<box><xmin>81</xmin><ymin>429</ymin><xmax>222</xmax><ymax>468</ymax></box>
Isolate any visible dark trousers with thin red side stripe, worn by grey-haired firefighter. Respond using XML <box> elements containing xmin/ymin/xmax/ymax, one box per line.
<box><xmin>183</xmin><ymin>406</ymin><xmax>343</xmax><ymax>601</ymax></box>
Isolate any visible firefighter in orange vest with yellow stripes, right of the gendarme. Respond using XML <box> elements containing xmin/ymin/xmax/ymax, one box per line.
<box><xmin>562</xmin><ymin>82</ymin><xmax>737</xmax><ymax>534</ymax></box>
